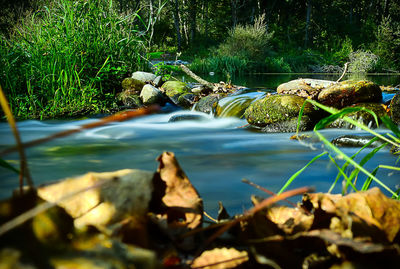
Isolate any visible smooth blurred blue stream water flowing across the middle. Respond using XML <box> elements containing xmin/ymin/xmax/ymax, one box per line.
<box><xmin>0</xmin><ymin>74</ymin><xmax>400</xmax><ymax>216</ymax></box>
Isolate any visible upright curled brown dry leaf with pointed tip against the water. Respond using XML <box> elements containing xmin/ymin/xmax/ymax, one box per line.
<box><xmin>157</xmin><ymin>152</ymin><xmax>203</xmax><ymax>229</ymax></box>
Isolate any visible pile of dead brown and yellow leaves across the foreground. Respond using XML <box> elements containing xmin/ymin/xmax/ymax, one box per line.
<box><xmin>0</xmin><ymin>152</ymin><xmax>400</xmax><ymax>268</ymax></box>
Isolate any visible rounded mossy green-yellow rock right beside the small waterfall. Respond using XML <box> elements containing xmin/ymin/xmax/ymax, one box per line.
<box><xmin>244</xmin><ymin>94</ymin><xmax>316</xmax><ymax>127</ymax></box>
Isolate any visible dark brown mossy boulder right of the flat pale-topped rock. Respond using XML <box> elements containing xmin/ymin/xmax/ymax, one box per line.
<box><xmin>318</xmin><ymin>80</ymin><xmax>382</xmax><ymax>108</ymax></box>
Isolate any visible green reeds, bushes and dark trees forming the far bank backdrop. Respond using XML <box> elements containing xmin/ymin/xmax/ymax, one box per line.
<box><xmin>0</xmin><ymin>0</ymin><xmax>400</xmax><ymax>119</ymax></box>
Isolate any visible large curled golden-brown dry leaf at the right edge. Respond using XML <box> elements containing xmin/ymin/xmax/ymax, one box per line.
<box><xmin>303</xmin><ymin>188</ymin><xmax>400</xmax><ymax>242</ymax></box>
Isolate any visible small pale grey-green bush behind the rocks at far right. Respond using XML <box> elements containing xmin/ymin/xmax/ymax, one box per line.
<box><xmin>349</xmin><ymin>50</ymin><xmax>379</xmax><ymax>73</ymax></box>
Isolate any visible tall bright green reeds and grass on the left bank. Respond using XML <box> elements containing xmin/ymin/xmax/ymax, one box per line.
<box><xmin>0</xmin><ymin>0</ymin><xmax>144</xmax><ymax>118</ymax></box>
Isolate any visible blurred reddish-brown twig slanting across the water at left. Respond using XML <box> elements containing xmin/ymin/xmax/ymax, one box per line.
<box><xmin>0</xmin><ymin>105</ymin><xmax>160</xmax><ymax>156</ymax></box>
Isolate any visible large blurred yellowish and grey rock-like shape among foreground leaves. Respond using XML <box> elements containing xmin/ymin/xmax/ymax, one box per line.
<box><xmin>38</xmin><ymin>169</ymin><xmax>153</xmax><ymax>228</ymax></box>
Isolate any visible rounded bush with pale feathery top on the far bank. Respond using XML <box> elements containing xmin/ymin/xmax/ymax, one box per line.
<box><xmin>217</xmin><ymin>15</ymin><xmax>273</xmax><ymax>61</ymax></box>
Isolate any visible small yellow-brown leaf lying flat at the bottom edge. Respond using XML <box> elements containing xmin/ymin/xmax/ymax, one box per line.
<box><xmin>191</xmin><ymin>248</ymin><xmax>249</xmax><ymax>269</ymax></box>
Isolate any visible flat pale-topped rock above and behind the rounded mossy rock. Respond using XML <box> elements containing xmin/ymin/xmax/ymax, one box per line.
<box><xmin>276</xmin><ymin>78</ymin><xmax>335</xmax><ymax>100</ymax></box>
